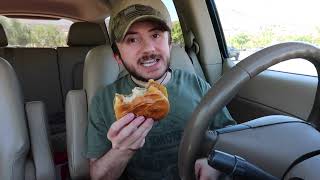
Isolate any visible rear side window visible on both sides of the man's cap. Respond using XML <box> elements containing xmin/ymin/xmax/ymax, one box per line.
<box><xmin>105</xmin><ymin>0</ymin><xmax>185</xmax><ymax>47</ymax></box>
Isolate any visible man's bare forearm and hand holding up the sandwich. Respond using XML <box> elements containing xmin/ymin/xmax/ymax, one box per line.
<box><xmin>90</xmin><ymin>113</ymin><xmax>153</xmax><ymax>180</ymax></box>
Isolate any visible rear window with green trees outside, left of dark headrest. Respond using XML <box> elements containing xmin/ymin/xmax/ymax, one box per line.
<box><xmin>0</xmin><ymin>16</ymin><xmax>72</xmax><ymax>47</ymax></box>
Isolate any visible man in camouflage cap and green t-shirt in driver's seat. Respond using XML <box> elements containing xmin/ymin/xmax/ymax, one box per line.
<box><xmin>87</xmin><ymin>0</ymin><xmax>234</xmax><ymax>180</ymax></box>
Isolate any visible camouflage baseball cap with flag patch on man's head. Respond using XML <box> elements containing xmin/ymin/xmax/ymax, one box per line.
<box><xmin>109</xmin><ymin>0</ymin><xmax>172</xmax><ymax>43</ymax></box>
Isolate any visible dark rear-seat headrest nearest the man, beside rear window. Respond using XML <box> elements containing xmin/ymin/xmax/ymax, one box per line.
<box><xmin>67</xmin><ymin>22</ymin><xmax>106</xmax><ymax>46</ymax></box>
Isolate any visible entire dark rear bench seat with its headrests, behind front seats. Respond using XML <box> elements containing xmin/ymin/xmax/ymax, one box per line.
<box><xmin>0</xmin><ymin>22</ymin><xmax>106</xmax><ymax>152</ymax></box>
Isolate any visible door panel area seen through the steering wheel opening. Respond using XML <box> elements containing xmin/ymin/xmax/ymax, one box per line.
<box><xmin>228</xmin><ymin>62</ymin><xmax>318</xmax><ymax>122</ymax></box>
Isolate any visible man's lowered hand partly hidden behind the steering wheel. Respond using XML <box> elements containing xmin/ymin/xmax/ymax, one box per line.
<box><xmin>194</xmin><ymin>158</ymin><xmax>220</xmax><ymax>180</ymax></box>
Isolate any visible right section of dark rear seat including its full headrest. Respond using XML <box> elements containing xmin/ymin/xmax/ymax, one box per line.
<box><xmin>57</xmin><ymin>22</ymin><xmax>106</xmax><ymax>99</ymax></box>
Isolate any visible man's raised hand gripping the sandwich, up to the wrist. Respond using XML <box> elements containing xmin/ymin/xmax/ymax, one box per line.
<box><xmin>107</xmin><ymin>113</ymin><xmax>154</xmax><ymax>151</ymax></box>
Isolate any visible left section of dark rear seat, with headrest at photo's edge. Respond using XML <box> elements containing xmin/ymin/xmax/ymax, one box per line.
<box><xmin>0</xmin><ymin>26</ymin><xmax>65</xmax><ymax>134</ymax></box>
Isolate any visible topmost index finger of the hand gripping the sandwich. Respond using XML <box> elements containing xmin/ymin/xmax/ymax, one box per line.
<box><xmin>107</xmin><ymin>113</ymin><xmax>134</xmax><ymax>140</ymax></box>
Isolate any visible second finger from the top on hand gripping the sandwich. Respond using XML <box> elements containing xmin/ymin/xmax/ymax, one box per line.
<box><xmin>113</xmin><ymin>116</ymin><xmax>145</xmax><ymax>143</ymax></box>
